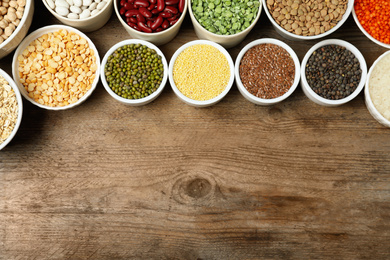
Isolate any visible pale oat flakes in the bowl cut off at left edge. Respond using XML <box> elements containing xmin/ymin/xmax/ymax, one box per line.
<box><xmin>0</xmin><ymin>75</ymin><xmax>18</xmax><ymax>144</ymax></box>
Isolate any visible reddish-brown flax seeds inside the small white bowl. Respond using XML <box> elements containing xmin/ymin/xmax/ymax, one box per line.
<box><xmin>240</xmin><ymin>43</ymin><xmax>295</xmax><ymax>99</ymax></box>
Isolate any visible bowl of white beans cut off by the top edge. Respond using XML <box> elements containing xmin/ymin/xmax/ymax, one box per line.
<box><xmin>42</xmin><ymin>0</ymin><xmax>113</xmax><ymax>32</ymax></box>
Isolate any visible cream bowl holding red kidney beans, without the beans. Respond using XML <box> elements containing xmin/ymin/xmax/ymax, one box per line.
<box><xmin>113</xmin><ymin>0</ymin><xmax>187</xmax><ymax>46</ymax></box>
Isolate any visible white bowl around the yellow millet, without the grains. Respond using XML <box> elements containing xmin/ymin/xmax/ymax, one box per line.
<box><xmin>169</xmin><ymin>40</ymin><xmax>234</xmax><ymax>107</ymax></box>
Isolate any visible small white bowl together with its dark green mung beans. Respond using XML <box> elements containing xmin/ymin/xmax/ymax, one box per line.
<box><xmin>100</xmin><ymin>39</ymin><xmax>168</xmax><ymax>106</ymax></box>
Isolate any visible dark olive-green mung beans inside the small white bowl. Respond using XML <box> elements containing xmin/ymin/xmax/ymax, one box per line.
<box><xmin>104</xmin><ymin>44</ymin><xmax>164</xmax><ymax>99</ymax></box>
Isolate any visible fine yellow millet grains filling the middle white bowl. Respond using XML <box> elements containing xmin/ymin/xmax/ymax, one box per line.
<box><xmin>173</xmin><ymin>44</ymin><xmax>230</xmax><ymax>101</ymax></box>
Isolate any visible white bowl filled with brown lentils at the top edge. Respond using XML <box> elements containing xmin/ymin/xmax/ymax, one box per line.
<box><xmin>263</xmin><ymin>0</ymin><xmax>354</xmax><ymax>40</ymax></box>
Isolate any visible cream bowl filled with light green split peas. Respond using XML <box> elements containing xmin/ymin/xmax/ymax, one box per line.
<box><xmin>188</xmin><ymin>0</ymin><xmax>262</xmax><ymax>48</ymax></box>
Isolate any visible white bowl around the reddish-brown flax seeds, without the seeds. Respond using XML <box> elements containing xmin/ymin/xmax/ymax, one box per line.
<box><xmin>234</xmin><ymin>38</ymin><xmax>301</xmax><ymax>106</ymax></box>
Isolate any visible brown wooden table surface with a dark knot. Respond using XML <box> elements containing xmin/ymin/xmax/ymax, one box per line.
<box><xmin>0</xmin><ymin>1</ymin><xmax>390</xmax><ymax>260</ymax></box>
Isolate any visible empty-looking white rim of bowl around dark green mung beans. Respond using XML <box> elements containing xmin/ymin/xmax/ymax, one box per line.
<box><xmin>100</xmin><ymin>39</ymin><xmax>168</xmax><ymax>106</ymax></box>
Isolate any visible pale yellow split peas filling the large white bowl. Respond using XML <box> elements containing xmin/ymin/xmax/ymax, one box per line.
<box><xmin>18</xmin><ymin>29</ymin><xmax>97</xmax><ymax>107</ymax></box>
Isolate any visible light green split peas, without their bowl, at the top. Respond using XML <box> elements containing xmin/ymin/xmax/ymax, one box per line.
<box><xmin>191</xmin><ymin>0</ymin><xmax>260</xmax><ymax>35</ymax></box>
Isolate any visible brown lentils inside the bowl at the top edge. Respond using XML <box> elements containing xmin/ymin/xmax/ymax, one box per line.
<box><xmin>267</xmin><ymin>0</ymin><xmax>348</xmax><ymax>36</ymax></box>
